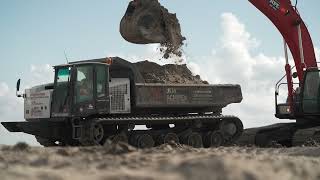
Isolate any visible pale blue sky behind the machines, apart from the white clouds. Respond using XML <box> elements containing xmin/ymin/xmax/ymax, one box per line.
<box><xmin>0</xmin><ymin>0</ymin><xmax>320</xmax><ymax>143</ymax></box>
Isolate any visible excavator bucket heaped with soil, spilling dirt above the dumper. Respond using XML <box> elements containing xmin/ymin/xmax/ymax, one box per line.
<box><xmin>120</xmin><ymin>0</ymin><xmax>185</xmax><ymax>57</ymax></box>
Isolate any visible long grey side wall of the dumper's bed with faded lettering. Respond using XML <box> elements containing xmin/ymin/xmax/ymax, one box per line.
<box><xmin>135</xmin><ymin>83</ymin><xmax>242</xmax><ymax>108</ymax></box>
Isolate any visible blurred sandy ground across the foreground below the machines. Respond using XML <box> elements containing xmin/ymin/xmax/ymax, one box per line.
<box><xmin>0</xmin><ymin>144</ymin><xmax>320</xmax><ymax>180</ymax></box>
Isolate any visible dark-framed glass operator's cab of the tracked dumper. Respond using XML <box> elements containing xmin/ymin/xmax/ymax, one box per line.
<box><xmin>51</xmin><ymin>62</ymin><xmax>110</xmax><ymax>117</ymax></box>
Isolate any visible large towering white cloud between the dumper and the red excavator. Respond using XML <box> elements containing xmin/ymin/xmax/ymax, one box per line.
<box><xmin>184</xmin><ymin>13</ymin><xmax>284</xmax><ymax>127</ymax></box>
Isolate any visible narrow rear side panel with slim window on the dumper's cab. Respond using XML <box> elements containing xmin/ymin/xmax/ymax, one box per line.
<box><xmin>95</xmin><ymin>64</ymin><xmax>110</xmax><ymax>114</ymax></box>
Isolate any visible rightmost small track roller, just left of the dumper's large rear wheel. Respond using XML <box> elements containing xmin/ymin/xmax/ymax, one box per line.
<box><xmin>203</xmin><ymin>131</ymin><xmax>224</xmax><ymax>148</ymax></box>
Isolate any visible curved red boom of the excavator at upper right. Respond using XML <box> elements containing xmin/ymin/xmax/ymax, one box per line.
<box><xmin>249</xmin><ymin>0</ymin><xmax>317</xmax><ymax>82</ymax></box>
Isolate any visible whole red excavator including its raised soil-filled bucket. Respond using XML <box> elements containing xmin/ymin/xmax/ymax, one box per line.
<box><xmin>120</xmin><ymin>0</ymin><xmax>320</xmax><ymax>147</ymax></box>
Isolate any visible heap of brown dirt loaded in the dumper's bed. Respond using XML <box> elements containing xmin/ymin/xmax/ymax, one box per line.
<box><xmin>135</xmin><ymin>61</ymin><xmax>208</xmax><ymax>84</ymax></box>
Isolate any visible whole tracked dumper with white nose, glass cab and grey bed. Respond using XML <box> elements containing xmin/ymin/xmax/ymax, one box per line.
<box><xmin>2</xmin><ymin>57</ymin><xmax>243</xmax><ymax>148</ymax></box>
